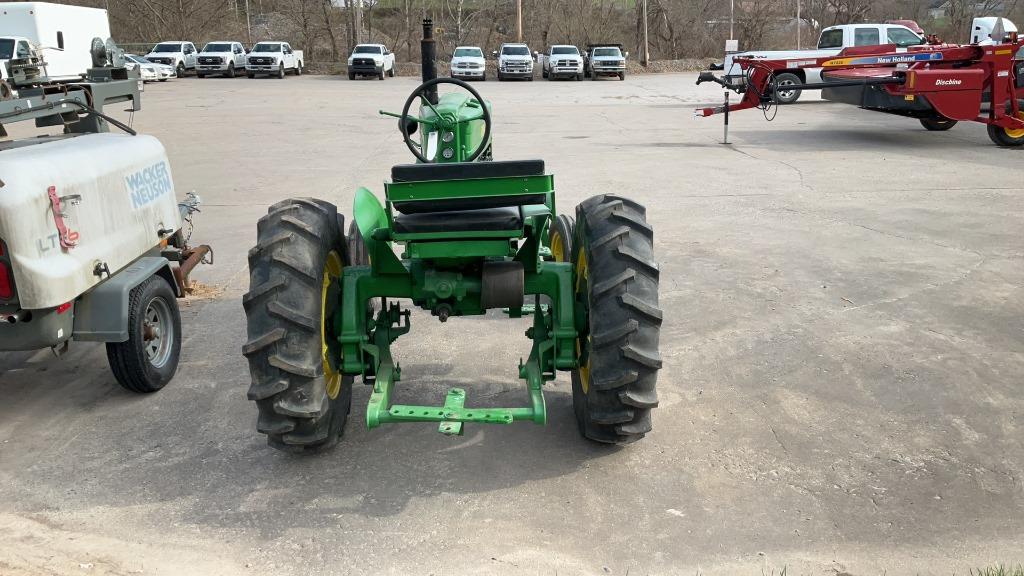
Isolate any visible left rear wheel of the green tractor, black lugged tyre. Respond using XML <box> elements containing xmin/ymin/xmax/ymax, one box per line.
<box><xmin>242</xmin><ymin>198</ymin><xmax>352</xmax><ymax>452</ymax></box>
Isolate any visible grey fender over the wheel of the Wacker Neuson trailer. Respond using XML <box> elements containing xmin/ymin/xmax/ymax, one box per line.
<box><xmin>74</xmin><ymin>256</ymin><xmax>182</xmax><ymax>342</ymax></box>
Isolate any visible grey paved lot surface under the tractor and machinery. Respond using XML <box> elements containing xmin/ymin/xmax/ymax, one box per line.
<box><xmin>0</xmin><ymin>74</ymin><xmax>1024</xmax><ymax>576</ymax></box>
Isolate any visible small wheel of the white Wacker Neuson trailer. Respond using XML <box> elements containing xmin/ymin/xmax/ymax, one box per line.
<box><xmin>106</xmin><ymin>276</ymin><xmax>181</xmax><ymax>393</ymax></box>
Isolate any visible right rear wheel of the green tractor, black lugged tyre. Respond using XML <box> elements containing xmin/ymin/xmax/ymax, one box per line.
<box><xmin>572</xmin><ymin>195</ymin><xmax>662</xmax><ymax>444</ymax></box>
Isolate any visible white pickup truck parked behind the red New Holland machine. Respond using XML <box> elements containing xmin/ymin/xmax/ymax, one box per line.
<box><xmin>722</xmin><ymin>24</ymin><xmax>925</xmax><ymax>104</ymax></box>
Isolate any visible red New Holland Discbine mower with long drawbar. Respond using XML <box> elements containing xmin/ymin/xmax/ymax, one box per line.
<box><xmin>696</xmin><ymin>21</ymin><xmax>1024</xmax><ymax>147</ymax></box>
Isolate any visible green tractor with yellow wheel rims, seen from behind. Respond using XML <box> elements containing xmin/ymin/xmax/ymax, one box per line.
<box><xmin>243</xmin><ymin>20</ymin><xmax>662</xmax><ymax>452</ymax></box>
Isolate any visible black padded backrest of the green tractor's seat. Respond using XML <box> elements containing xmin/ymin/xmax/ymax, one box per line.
<box><xmin>391</xmin><ymin>160</ymin><xmax>547</xmax><ymax>214</ymax></box>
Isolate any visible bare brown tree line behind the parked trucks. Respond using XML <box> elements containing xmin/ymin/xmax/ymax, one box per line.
<box><xmin>36</xmin><ymin>0</ymin><xmax>1024</xmax><ymax>61</ymax></box>
